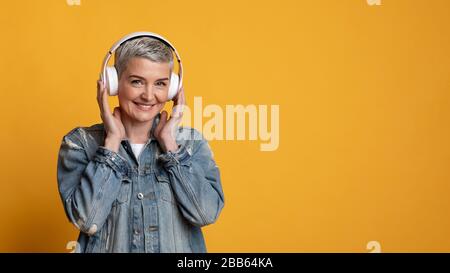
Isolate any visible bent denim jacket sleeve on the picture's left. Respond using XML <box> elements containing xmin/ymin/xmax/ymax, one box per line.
<box><xmin>57</xmin><ymin>128</ymin><xmax>127</xmax><ymax>235</ymax></box>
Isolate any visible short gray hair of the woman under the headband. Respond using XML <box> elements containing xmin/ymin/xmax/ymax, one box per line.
<box><xmin>114</xmin><ymin>37</ymin><xmax>173</xmax><ymax>79</ymax></box>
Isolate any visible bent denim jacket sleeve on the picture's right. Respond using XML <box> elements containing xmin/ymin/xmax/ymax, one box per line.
<box><xmin>159</xmin><ymin>129</ymin><xmax>225</xmax><ymax>227</ymax></box>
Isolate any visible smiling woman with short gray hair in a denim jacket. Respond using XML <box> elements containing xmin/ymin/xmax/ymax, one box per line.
<box><xmin>58</xmin><ymin>37</ymin><xmax>224</xmax><ymax>253</ymax></box>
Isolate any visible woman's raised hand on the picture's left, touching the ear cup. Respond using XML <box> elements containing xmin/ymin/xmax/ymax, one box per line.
<box><xmin>97</xmin><ymin>80</ymin><xmax>126</xmax><ymax>152</ymax></box>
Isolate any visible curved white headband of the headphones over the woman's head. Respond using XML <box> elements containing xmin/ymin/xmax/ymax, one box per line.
<box><xmin>100</xmin><ymin>31</ymin><xmax>183</xmax><ymax>91</ymax></box>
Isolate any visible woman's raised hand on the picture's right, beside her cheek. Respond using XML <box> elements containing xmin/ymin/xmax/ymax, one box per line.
<box><xmin>153</xmin><ymin>87</ymin><xmax>186</xmax><ymax>152</ymax></box>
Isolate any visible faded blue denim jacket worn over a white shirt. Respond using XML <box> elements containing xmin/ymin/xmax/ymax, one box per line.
<box><xmin>57</xmin><ymin>114</ymin><xmax>224</xmax><ymax>253</ymax></box>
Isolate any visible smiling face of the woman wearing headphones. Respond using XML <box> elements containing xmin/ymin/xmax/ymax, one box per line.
<box><xmin>118</xmin><ymin>57</ymin><xmax>171</xmax><ymax>122</ymax></box>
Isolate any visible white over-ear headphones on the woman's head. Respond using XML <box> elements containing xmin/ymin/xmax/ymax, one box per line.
<box><xmin>100</xmin><ymin>32</ymin><xmax>183</xmax><ymax>100</ymax></box>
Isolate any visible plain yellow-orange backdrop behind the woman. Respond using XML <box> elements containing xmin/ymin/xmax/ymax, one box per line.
<box><xmin>0</xmin><ymin>0</ymin><xmax>450</xmax><ymax>252</ymax></box>
